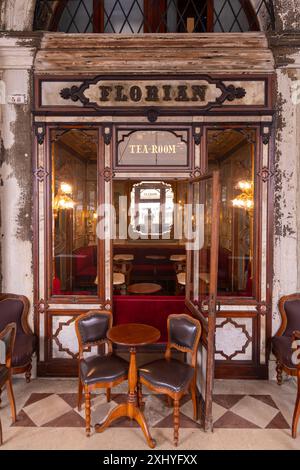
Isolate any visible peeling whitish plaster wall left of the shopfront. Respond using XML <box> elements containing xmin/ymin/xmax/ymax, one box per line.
<box><xmin>0</xmin><ymin>59</ymin><xmax>33</xmax><ymax>324</ymax></box>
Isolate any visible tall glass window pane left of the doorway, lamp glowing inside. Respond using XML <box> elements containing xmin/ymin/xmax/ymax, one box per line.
<box><xmin>51</xmin><ymin>129</ymin><xmax>98</xmax><ymax>295</ymax></box>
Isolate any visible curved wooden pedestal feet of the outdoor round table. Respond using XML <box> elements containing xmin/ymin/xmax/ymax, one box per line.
<box><xmin>95</xmin><ymin>403</ymin><xmax>156</xmax><ymax>449</ymax></box>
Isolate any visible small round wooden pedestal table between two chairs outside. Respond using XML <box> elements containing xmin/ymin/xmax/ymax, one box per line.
<box><xmin>95</xmin><ymin>323</ymin><xmax>160</xmax><ymax>449</ymax></box>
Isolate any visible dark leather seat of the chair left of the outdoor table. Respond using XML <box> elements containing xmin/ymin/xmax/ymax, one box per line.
<box><xmin>80</xmin><ymin>355</ymin><xmax>128</xmax><ymax>385</ymax></box>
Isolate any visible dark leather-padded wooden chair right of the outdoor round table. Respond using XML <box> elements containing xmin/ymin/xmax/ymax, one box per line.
<box><xmin>139</xmin><ymin>314</ymin><xmax>201</xmax><ymax>446</ymax></box>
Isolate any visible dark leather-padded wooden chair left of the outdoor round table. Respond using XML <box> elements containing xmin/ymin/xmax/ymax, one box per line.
<box><xmin>75</xmin><ymin>310</ymin><xmax>128</xmax><ymax>436</ymax></box>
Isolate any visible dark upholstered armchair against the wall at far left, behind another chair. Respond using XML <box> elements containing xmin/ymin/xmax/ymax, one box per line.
<box><xmin>0</xmin><ymin>294</ymin><xmax>37</xmax><ymax>383</ymax></box>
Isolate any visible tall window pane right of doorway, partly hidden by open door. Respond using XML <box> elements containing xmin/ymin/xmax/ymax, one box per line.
<box><xmin>207</xmin><ymin>129</ymin><xmax>255</xmax><ymax>297</ymax></box>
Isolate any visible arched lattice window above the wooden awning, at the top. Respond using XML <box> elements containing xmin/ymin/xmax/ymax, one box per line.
<box><xmin>33</xmin><ymin>0</ymin><xmax>274</xmax><ymax>34</ymax></box>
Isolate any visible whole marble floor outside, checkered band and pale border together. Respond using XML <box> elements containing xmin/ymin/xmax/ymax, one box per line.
<box><xmin>0</xmin><ymin>378</ymin><xmax>300</xmax><ymax>450</ymax></box>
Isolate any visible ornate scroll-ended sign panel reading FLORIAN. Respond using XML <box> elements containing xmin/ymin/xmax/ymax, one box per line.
<box><xmin>60</xmin><ymin>76</ymin><xmax>246</xmax><ymax>110</ymax></box>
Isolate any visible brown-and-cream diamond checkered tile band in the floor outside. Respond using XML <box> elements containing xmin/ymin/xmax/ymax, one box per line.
<box><xmin>13</xmin><ymin>393</ymin><xmax>289</xmax><ymax>429</ymax></box>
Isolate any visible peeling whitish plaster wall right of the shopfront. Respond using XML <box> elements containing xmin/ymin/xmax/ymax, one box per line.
<box><xmin>273</xmin><ymin>69</ymin><xmax>300</xmax><ymax>333</ymax></box>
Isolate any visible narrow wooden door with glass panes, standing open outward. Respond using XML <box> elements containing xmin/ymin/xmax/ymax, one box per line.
<box><xmin>186</xmin><ymin>171</ymin><xmax>220</xmax><ymax>431</ymax></box>
